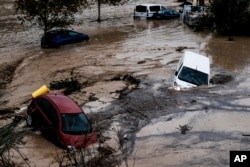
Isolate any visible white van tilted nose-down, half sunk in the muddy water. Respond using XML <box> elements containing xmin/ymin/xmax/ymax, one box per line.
<box><xmin>173</xmin><ymin>50</ymin><xmax>210</xmax><ymax>90</ymax></box>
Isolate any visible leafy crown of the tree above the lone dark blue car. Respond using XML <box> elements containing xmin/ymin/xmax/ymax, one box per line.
<box><xmin>15</xmin><ymin>0</ymin><xmax>88</xmax><ymax>33</ymax></box>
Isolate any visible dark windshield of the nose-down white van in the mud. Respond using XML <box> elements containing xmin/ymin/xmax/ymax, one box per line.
<box><xmin>178</xmin><ymin>66</ymin><xmax>208</xmax><ymax>86</ymax></box>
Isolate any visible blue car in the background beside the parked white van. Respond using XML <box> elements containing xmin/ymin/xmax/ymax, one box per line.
<box><xmin>153</xmin><ymin>9</ymin><xmax>180</xmax><ymax>19</ymax></box>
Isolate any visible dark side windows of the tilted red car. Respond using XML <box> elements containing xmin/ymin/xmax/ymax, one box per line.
<box><xmin>37</xmin><ymin>98</ymin><xmax>59</xmax><ymax>127</ymax></box>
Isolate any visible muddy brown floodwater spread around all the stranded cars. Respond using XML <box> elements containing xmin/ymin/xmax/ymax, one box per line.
<box><xmin>0</xmin><ymin>0</ymin><xmax>250</xmax><ymax>167</ymax></box>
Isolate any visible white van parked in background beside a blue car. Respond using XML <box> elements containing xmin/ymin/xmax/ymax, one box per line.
<box><xmin>134</xmin><ymin>4</ymin><xmax>166</xmax><ymax>19</ymax></box>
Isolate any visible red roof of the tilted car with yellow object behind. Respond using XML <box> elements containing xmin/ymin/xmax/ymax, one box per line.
<box><xmin>41</xmin><ymin>93</ymin><xmax>83</xmax><ymax>114</ymax></box>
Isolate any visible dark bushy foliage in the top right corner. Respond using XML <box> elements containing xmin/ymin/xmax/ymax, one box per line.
<box><xmin>210</xmin><ymin>0</ymin><xmax>250</xmax><ymax>35</ymax></box>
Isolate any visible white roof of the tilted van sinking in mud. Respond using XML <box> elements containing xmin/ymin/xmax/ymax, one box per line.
<box><xmin>182</xmin><ymin>50</ymin><xmax>210</xmax><ymax>74</ymax></box>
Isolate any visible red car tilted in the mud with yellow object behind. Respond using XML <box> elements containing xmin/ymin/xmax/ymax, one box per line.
<box><xmin>27</xmin><ymin>93</ymin><xmax>97</xmax><ymax>148</ymax></box>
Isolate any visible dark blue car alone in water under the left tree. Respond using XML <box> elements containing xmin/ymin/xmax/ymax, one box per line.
<box><xmin>41</xmin><ymin>29</ymin><xmax>89</xmax><ymax>48</ymax></box>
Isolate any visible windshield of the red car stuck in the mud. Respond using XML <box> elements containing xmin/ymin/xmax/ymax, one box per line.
<box><xmin>62</xmin><ymin>113</ymin><xmax>91</xmax><ymax>135</ymax></box>
